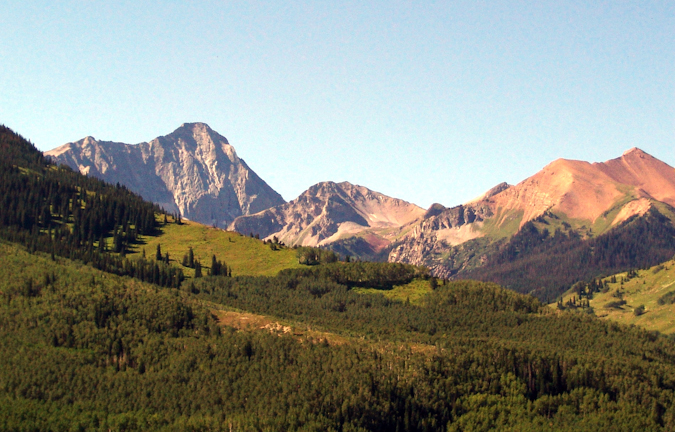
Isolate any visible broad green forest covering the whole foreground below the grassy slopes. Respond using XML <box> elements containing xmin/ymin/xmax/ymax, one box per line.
<box><xmin>0</xmin><ymin>243</ymin><xmax>675</xmax><ymax>431</ymax></box>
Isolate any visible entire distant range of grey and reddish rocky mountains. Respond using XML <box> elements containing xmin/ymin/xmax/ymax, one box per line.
<box><xmin>46</xmin><ymin>123</ymin><xmax>675</xmax><ymax>298</ymax></box>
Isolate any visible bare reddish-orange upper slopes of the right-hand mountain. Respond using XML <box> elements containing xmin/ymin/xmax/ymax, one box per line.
<box><xmin>492</xmin><ymin>148</ymin><xmax>675</xmax><ymax>226</ymax></box>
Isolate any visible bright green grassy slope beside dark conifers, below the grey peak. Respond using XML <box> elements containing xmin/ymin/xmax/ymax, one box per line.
<box><xmin>129</xmin><ymin>219</ymin><xmax>300</xmax><ymax>277</ymax></box>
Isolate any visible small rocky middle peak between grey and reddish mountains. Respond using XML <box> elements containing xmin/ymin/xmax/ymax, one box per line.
<box><xmin>230</xmin><ymin>182</ymin><xmax>424</xmax><ymax>252</ymax></box>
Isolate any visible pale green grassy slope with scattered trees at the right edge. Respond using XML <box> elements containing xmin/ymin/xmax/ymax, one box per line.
<box><xmin>551</xmin><ymin>261</ymin><xmax>675</xmax><ymax>334</ymax></box>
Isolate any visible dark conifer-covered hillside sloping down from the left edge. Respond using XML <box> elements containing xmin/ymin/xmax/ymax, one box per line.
<box><xmin>0</xmin><ymin>126</ymin><xmax>183</xmax><ymax>287</ymax></box>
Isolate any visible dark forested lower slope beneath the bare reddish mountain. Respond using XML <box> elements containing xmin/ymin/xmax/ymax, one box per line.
<box><xmin>458</xmin><ymin>213</ymin><xmax>675</xmax><ymax>302</ymax></box>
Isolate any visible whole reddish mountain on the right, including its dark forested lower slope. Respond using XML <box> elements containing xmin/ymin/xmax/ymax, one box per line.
<box><xmin>387</xmin><ymin>148</ymin><xmax>675</xmax><ymax>299</ymax></box>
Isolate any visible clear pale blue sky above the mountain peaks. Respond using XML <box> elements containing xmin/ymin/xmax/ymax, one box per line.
<box><xmin>0</xmin><ymin>0</ymin><xmax>675</xmax><ymax>207</ymax></box>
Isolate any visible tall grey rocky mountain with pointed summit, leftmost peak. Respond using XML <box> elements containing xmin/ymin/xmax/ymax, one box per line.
<box><xmin>45</xmin><ymin>123</ymin><xmax>285</xmax><ymax>226</ymax></box>
